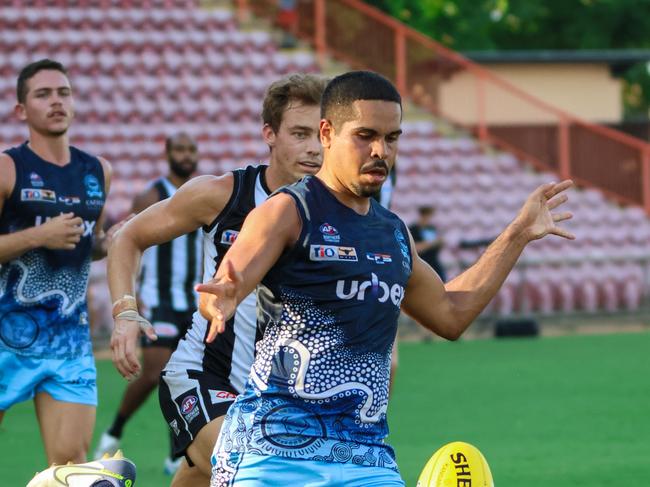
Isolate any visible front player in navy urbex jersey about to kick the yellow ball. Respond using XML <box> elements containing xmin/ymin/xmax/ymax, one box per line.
<box><xmin>197</xmin><ymin>71</ymin><xmax>573</xmax><ymax>487</ymax></box>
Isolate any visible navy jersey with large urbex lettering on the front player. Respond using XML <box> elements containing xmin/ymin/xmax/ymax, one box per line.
<box><xmin>219</xmin><ymin>177</ymin><xmax>412</xmax><ymax>469</ymax></box>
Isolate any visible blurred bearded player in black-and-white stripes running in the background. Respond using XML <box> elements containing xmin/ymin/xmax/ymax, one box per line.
<box><xmin>94</xmin><ymin>133</ymin><xmax>202</xmax><ymax>474</ymax></box>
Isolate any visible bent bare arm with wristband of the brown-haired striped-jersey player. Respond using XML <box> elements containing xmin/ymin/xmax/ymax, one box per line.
<box><xmin>108</xmin><ymin>174</ymin><xmax>233</xmax><ymax>378</ymax></box>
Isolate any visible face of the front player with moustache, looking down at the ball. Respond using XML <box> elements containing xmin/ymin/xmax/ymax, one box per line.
<box><xmin>321</xmin><ymin>100</ymin><xmax>402</xmax><ymax>198</ymax></box>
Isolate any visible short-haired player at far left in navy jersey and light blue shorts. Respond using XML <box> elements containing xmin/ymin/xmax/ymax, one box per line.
<box><xmin>0</xmin><ymin>59</ymin><xmax>118</xmax><ymax>464</ymax></box>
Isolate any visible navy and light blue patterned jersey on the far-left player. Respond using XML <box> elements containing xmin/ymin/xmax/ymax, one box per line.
<box><xmin>0</xmin><ymin>143</ymin><xmax>106</xmax><ymax>358</ymax></box>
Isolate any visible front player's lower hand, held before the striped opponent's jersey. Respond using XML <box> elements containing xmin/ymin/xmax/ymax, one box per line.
<box><xmin>194</xmin><ymin>261</ymin><xmax>242</xmax><ymax>343</ymax></box>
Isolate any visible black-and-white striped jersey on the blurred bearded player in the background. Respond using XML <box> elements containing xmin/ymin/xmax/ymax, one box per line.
<box><xmin>138</xmin><ymin>177</ymin><xmax>202</xmax><ymax>312</ymax></box>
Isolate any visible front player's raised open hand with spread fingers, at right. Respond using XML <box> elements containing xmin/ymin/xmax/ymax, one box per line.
<box><xmin>513</xmin><ymin>179</ymin><xmax>575</xmax><ymax>242</ymax></box>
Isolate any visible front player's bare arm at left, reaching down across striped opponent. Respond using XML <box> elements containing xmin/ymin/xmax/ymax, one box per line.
<box><xmin>196</xmin><ymin>193</ymin><xmax>302</xmax><ymax>343</ymax></box>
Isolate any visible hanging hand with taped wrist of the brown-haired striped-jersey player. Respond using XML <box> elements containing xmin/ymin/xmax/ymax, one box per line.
<box><xmin>111</xmin><ymin>311</ymin><xmax>158</xmax><ymax>380</ymax></box>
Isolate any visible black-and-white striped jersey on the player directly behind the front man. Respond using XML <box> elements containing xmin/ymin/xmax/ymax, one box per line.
<box><xmin>165</xmin><ymin>165</ymin><xmax>270</xmax><ymax>392</ymax></box>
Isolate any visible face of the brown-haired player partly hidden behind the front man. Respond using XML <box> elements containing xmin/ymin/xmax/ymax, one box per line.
<box><xmin>264</xmin><ymin>102</ymin><xmax>323</xmax><ymax>183</ymax></box>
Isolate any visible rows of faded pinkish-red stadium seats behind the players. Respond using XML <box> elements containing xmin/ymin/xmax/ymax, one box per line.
<box><xmin>0</xmin><ymin>0</ymin><xmax>650</xmax><ymax>314</ymax></box>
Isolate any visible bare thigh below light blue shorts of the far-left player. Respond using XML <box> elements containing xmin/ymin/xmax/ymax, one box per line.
<box><xmin>34</xmin><ymin>392</ymin><xmax>95</xmax><ymax>464</ymax></box>
